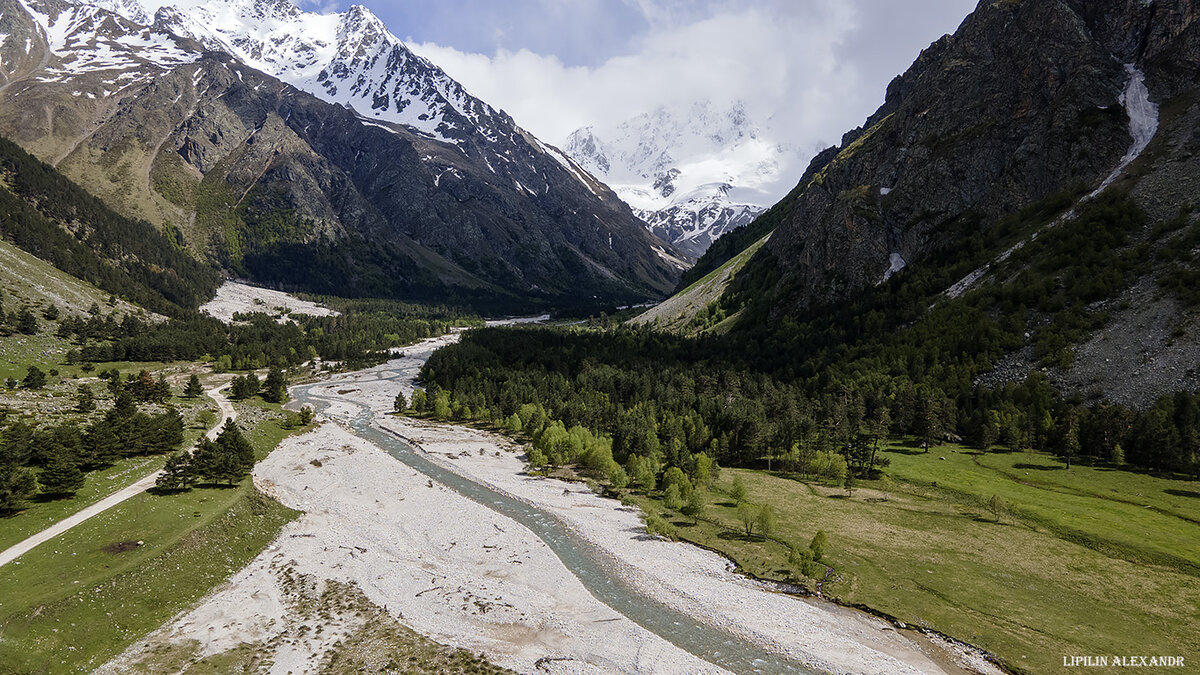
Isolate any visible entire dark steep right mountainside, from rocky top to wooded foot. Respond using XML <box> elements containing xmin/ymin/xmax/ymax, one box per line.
<box><xmin>643</xmin><ymin>0</ymin><xmax>1200</xmax><ymax>406</ymax></box>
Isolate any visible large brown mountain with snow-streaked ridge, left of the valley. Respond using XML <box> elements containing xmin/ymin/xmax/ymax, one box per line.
<box><xmin>0</xmin><ymin>0</ymin><xmax>682</xmax><ymax>309</ymax></box>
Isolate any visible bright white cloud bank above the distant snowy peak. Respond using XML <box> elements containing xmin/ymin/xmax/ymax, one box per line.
<box><xmin>410</xmin><ymin>0</ymin><xmax>970</xmax><ymax>197</ymax></box>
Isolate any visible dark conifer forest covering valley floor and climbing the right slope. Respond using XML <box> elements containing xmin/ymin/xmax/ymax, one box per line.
<box><xmin>424</xmin><ymin>191</ymin><xmax>1200</xmax><ymax>477</ymax></box>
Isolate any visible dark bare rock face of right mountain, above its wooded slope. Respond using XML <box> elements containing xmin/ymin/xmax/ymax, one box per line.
<box><xmin>739</xmin><ymin>1</ymin><xmax>1195</xmax><ymax>306</ymax></box>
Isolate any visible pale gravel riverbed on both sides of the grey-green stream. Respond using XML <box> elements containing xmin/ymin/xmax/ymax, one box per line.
<box><xmin>100</xmin><ymin>335</ymin><xmax>995</xmax><ymax>675</ymax></box>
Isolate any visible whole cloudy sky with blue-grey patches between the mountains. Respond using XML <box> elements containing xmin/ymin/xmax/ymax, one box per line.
<box><xmin>310</xmin><ymin>0</ymin><xmax>976</xmax><ymax>184</ymax></box>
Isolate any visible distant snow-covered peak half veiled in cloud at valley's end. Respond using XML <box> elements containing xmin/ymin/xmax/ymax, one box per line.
<box><xmin>564</xmin><ymin>101</ymin><xmax>777</xmax><ymax>256</ymax></box>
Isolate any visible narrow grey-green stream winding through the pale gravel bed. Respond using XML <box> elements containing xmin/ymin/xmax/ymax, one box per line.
<box><xmin>293</xmin><ymin>345</ymin><xmax>814</xmax><ymax>674</ymax></box>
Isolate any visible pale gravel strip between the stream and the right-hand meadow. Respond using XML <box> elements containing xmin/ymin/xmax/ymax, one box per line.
<box><xmin>380</xmin><ymin>417</ymin><xmax>1001</xmax><ymax>674</ymax></box>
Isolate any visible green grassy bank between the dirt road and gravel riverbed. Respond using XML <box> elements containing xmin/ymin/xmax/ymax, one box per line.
<box><xmin>0</xmin><ymin>404</ymin><xmax>298</xmax><ymax>674</ymax></box>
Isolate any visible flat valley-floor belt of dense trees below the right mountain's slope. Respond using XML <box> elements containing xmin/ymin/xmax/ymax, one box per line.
<box><xmin>412</xmin><ymin>299</ymin><xmax>1200</xmax><ymax>478</ymax></box>
